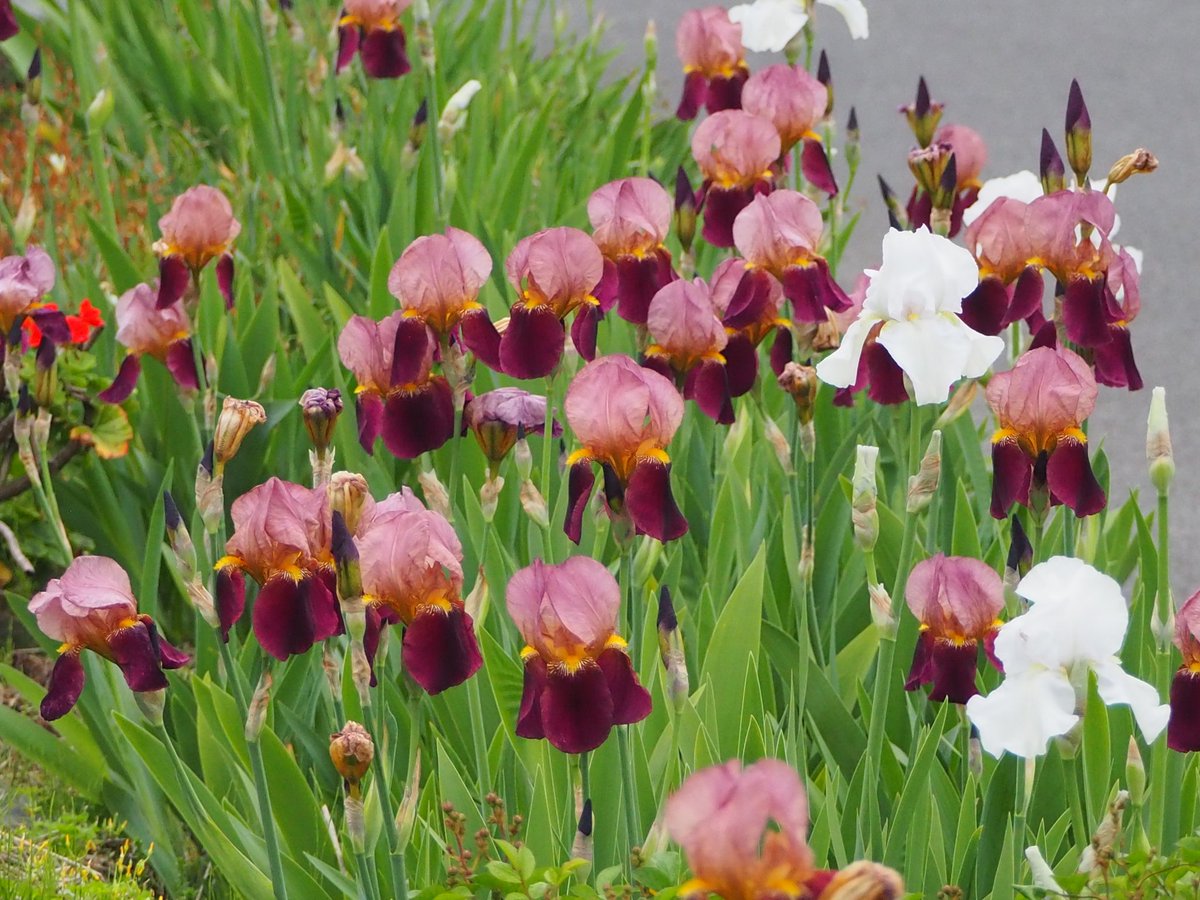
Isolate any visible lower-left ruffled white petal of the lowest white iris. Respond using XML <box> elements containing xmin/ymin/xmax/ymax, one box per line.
<box><xmin>967</xmin><ymin>668</ymin><xmax>1079</xmax><ymax>758</ymax></box>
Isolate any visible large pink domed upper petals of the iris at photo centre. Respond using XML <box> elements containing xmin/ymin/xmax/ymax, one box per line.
<box><xmin>564</xmin><ymin>355</ymin><xmax>683</xmax><ymax>457</ymax></box>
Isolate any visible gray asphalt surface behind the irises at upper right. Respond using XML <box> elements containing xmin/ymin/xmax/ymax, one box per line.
<box><xmin>563</xmin><ymin>0</ymin><xmax>1200</xmax><ymax>602</ymax></box>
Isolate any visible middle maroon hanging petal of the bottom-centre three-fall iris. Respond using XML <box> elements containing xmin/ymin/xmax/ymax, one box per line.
<box><xmin>539</xmin><ymin>660</ymin><xmax>613</xmax><ymax>754</ymax></box>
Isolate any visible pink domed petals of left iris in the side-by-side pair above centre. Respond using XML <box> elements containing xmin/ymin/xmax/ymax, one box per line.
<box><xmin>388</xmin><ymin>228</ymin><xmax>492</xmax><ymax>335</ymax></box>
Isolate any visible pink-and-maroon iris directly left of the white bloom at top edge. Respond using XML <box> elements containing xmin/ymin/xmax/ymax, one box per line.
<box><xmin>676</xmin><ymin>6</ymin><xmax>750</xmax><ymax>120</ymax></box>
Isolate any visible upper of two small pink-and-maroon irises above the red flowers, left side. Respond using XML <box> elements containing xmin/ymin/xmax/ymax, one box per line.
<box><xmin>154</xmin><ymin>185</ymin><xmax>241</xmax><ymax>310</ymax></box>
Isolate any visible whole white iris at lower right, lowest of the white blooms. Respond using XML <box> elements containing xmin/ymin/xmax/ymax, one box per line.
<box><xmin>967</xmin><ymin>557</ymin><xmax>1170</xmax><ymax>758</ymax></box>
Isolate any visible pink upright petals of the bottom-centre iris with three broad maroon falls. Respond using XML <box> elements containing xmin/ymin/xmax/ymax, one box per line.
<box><xmin>505</xmin><ymin>557</ymin><xmax>620</xmax><ymax>661</ymax></box>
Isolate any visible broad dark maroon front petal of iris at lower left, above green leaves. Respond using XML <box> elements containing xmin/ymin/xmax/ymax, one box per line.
<box><xmin>252</xmin><ymin>575</ymin><xmax>341</xmax><ymax>660</ymax></box>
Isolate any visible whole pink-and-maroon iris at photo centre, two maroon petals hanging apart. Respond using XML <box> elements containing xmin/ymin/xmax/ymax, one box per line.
<box><xmin>563</xmin><ymin>355</ymin><xmax>688</xmax><ymax>544</ymax></box>
